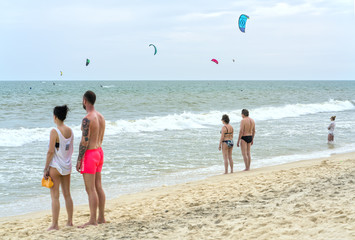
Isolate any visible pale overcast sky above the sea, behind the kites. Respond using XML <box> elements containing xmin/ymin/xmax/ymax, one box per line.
<box><xmin>0</xmin><ymin>0</ymin><xmax>355</xmax><ymax>80</ymax></box>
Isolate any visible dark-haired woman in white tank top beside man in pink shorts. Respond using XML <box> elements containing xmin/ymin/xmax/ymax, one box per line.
<box><xmin>43</xmin><ymin>105</ymin><xmax>74</xmax><ymax>230</ymax></box>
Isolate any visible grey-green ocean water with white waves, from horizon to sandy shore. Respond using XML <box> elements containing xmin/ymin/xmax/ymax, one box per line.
<box><xmin>0</xmin><ymin>81</ymin><xmax>355</xmax><ymax>217</ymax></box>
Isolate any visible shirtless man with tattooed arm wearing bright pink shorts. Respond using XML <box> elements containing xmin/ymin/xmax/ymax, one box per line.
<box><xmin>76</xmin><ymin>91</ymin><xmax>106</xmax><ymax>228</ymax></box>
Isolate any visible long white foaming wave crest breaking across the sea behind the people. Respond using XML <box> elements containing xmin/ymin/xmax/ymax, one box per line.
<box><xmin>0</xmin><ymin>99</ymin><xmax>355</xmax><ymax>147</ymax></box>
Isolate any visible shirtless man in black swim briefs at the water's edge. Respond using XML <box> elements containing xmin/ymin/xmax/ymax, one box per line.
<box><xmin>237</xmin><ymin>109</ymin><xmax>255</xmax><ymax>171</ymax></box>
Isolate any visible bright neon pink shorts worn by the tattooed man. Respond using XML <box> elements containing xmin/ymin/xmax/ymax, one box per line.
<box><xmin>80</xmin><ymin>148</ymin><xmax>104</xmax><ymax>174</ymax></box>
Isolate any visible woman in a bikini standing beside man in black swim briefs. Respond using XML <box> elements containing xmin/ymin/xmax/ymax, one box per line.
<box><xmin>218</xmin><ymin>114</ymin><xmax>233</xmax><ymax>174</ymax></box>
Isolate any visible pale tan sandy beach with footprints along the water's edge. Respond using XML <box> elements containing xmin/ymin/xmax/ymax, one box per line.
<box><xmin>0</xmin><ymin>153</ymin><xmax>355</xmax><ymax>240</ymax></box>
